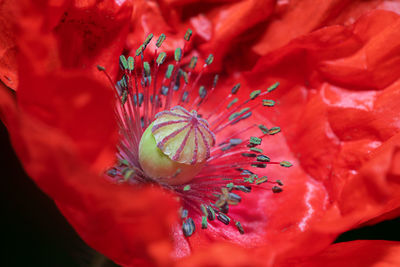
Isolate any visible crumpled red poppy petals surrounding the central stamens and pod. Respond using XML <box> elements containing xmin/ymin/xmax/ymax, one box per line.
<box><xmin>0</xmin><ymin>1</ymin><xmax>400</xmax><ymax>266</ymax></box>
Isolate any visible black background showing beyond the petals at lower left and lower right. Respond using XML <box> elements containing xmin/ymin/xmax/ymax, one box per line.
<box><xmin>0</xmin><ymin>123</ymin><xmax>400</xmax><ymax>267</ymax></box>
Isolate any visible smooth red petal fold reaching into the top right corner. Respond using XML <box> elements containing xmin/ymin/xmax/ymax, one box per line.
<box><xmin>253</xmin><ymin>0</ymin><xmax>400</xmax><ymax>55</ymax></box>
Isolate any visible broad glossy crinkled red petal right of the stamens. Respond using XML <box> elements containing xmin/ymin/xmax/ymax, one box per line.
<box><xmin>247</xmin><ymin>11</ymin><xmax>400</xmax><ymax>256</ymax></box>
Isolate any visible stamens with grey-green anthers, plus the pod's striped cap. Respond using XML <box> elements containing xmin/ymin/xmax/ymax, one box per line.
<box><xmin>98</xmin><ymin>30</ymin><xmax>291</xmax><ymax>237</ymax></box>
